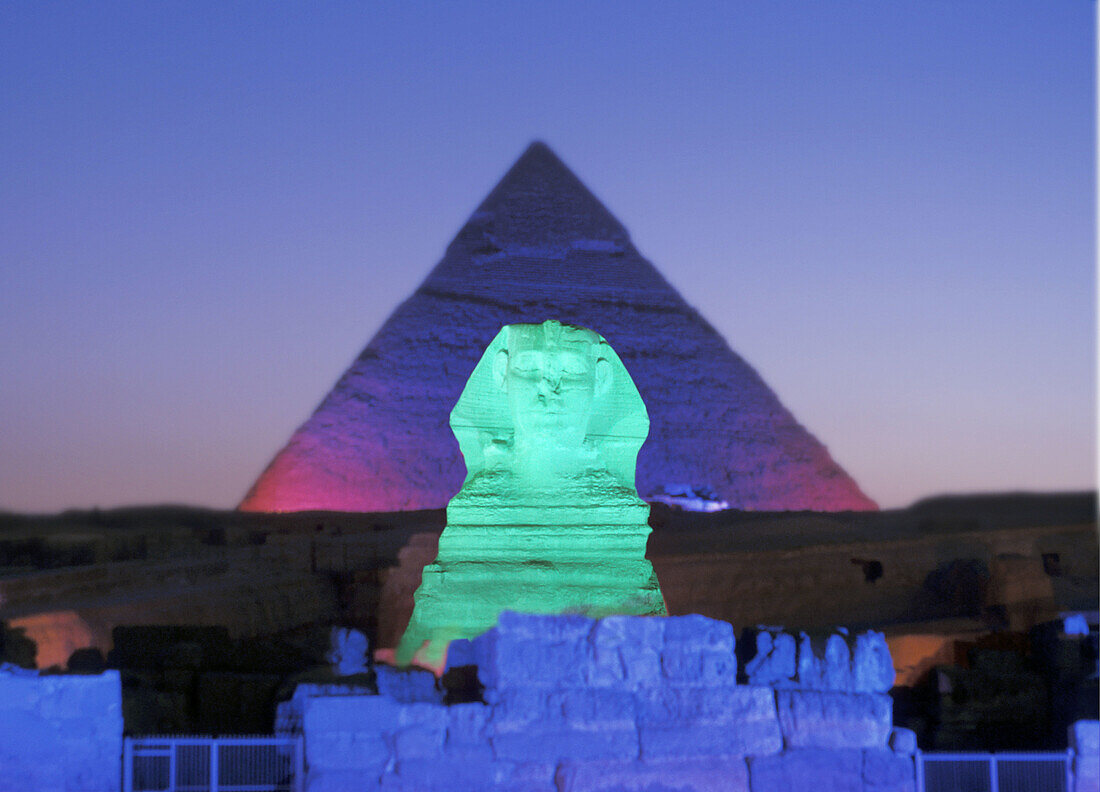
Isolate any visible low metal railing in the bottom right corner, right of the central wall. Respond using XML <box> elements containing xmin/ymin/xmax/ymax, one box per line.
<box><xmin>914</xmin><ymin>750</ymin><xmax>1074</xmax><ymax>792</ymax></box>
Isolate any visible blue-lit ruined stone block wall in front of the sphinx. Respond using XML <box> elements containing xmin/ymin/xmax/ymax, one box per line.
<box><xmin>278</xmin><ymin>614</ymin><xmax>916</xmax><ymax>792</ymax></box>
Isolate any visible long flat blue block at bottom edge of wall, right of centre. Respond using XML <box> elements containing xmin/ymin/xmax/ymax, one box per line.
<box><xmin>556</xmin><ymin>757</ymin><xmax>749</xmax><ymax>792</ymax></box>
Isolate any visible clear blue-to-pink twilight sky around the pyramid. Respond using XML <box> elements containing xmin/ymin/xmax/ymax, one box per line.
<box><xmin>0</xmin><ymin>0</ymin><xmax>1096</xmax><ymax>510</ymax></box>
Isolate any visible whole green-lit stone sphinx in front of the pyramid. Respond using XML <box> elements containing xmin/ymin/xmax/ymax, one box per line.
<box><xmin>395</xmin><ymin>320</ymin><xmax>666</xmax><ymax>669</ymax></box>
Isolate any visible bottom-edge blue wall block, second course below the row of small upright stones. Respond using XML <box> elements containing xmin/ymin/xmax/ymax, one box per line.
<box><xmin>749</xmin><ymin>748</ymin><xmax>864</xmax><ymax>792</ymax></box>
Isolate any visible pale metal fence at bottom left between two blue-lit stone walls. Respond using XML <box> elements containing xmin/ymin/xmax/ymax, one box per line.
<box><xmin>122</xmin><ymin>736</ymin><xmax>305</xmax><ymax>792</ymax></box>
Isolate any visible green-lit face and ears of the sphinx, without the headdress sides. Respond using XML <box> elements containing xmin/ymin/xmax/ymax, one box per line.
<box><xmin>493</xmin><ymin>320</ymin><xmax>612</xmax><ymax>449</ymax></box>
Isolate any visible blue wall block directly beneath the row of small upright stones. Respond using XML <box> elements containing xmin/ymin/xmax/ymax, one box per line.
<box><xmin>776</xmin><ymin>690</ymin><xmax>892</xmax><ymax>748</ymax></box>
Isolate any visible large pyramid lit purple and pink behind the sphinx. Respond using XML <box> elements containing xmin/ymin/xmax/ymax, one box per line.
<box><xmin>240</xmin><ymin>142</ymin><xmax>877</xmax><ymax>512</ymax></box>
